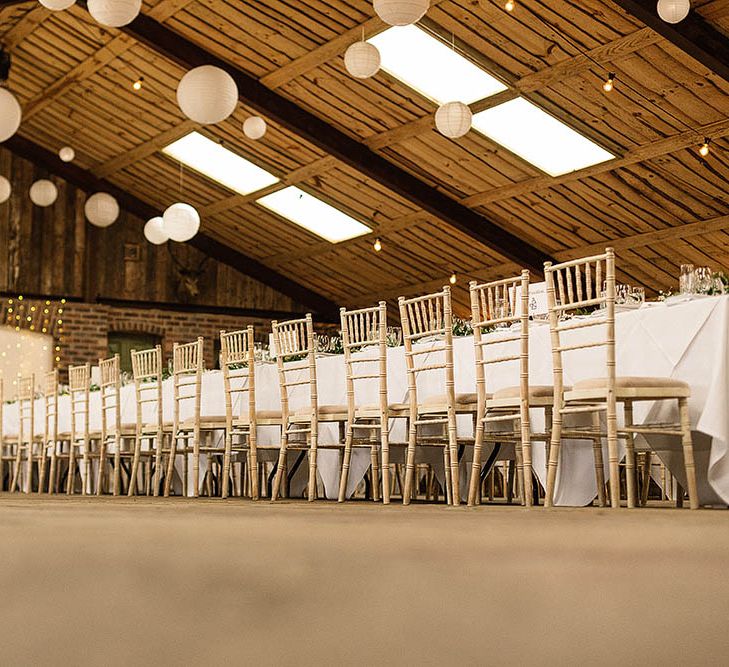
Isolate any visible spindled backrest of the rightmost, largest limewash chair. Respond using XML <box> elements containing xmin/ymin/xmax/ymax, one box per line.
<box><xmin>544</xmin><ymin>248</ymin><xmax>615</xmax><ymax>396</ymax></box>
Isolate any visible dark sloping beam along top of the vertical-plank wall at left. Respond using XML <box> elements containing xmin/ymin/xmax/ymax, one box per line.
<box><xmin>3</xmin><ymin>134</ymin><xmax>338</xmax><ymax>318</ymax></box>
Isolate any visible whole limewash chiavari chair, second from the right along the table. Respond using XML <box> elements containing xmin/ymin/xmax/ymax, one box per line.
<box><xmin>468</xmin><ymin>271</ymin><xmax>536</xmax><ymax>506</ymax></box>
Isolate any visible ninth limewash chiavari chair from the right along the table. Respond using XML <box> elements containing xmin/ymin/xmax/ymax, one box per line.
<box><xmin>96</xmin><ymin>354</ymin><xmax>136</xmax><ymax>496</ymax></box>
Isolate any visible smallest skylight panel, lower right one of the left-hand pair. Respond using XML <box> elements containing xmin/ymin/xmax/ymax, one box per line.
<box><xmin>258</xmin><ymin>186</ymin><xmax>371</xmax><ymax>243</ymax></box>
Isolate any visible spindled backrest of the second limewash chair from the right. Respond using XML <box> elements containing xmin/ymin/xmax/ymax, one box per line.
<box><xmin>469</xmin><ymin>270</ymin><xmax>529</xmax><ymax>404</ymax></box>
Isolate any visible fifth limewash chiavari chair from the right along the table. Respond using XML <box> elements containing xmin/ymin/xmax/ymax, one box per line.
<box><xmin>271</xmin><ymin>314</ymin><xmax>347</xmax><ymax>502</ymax></box>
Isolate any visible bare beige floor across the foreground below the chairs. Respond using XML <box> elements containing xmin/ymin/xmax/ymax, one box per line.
<box><xmin>0</xmin><ymin>494</ymin><xmax>729</xmax><ymax>666</ymax></box>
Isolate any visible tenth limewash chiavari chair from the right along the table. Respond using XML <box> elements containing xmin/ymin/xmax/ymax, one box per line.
<box><xmin>66</xmin><ymin>363</ymin><xmax>100</xmax><ymax>495</ymax></box>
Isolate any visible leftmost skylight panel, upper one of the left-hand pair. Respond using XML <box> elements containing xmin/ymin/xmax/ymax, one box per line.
<box><xmin>162</xmin><ymin>132</ymin><xmax>279</xmax><ymax>195</ymax></box>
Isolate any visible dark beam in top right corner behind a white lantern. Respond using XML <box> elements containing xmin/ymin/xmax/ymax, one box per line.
<box><xmin>613</xmin><ymin>0</ymin><xmax>729</xmax><ymax>81</ymax></box>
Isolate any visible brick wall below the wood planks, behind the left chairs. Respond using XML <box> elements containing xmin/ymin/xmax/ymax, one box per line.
<box><xmin>59</xmin><ymin>302</ymin><xmax>271</xmax><ymax>370</ymax></box>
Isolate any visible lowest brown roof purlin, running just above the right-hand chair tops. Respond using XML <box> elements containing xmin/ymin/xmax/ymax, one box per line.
<box><xmin>352</xmin><ymin>215</ymin><xmax>729</xmax><ymax>305</ymax></box>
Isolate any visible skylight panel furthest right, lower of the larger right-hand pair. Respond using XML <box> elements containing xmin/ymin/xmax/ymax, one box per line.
<box><xmin>466</xmin><ymin>97</ymin><xmax>615</xmax><ymax>176</ymax></box>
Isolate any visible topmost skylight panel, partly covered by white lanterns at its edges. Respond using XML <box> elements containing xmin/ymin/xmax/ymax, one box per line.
<box><xmin>368</xmin><ymin>25</ymin><xmax>506</xmax><ymax>104</ymax></box>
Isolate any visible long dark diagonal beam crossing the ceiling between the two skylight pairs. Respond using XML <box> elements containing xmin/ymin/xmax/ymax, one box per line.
<box><xmin>111</xmin><ymin>8</ymin><xmax>545</xmax><ymax>272</ymax></box>
